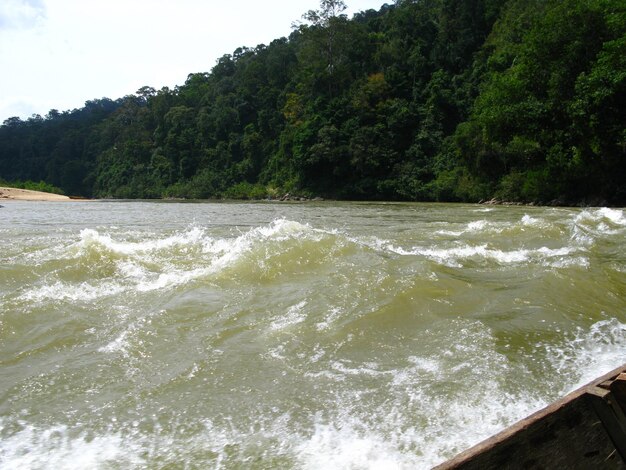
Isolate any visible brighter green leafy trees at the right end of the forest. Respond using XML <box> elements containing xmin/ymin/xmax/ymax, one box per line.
<box><xmin>457</xmin><ymin>0</ymin><xmax>626</xmax><ymax>203</ymax></box>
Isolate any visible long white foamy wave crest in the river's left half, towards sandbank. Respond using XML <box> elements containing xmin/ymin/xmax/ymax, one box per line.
<box><xmin>19</xmin><ymin>219</ymin><xmax>321</xmax><ymax>302</ymax></box>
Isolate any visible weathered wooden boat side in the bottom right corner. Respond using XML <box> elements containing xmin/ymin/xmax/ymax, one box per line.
<box><xmin>435</xmin><ymin>364</ymin><xmax>626</xmax><ymax>470</ymax></box>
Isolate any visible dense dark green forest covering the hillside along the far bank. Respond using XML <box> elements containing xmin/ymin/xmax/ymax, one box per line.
<box><xmin>0</xmin><ymin>0</ymin><xmax>626</xmax><ymax>205</ymax></box>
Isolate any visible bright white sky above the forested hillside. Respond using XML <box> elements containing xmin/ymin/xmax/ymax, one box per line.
<box><xmin>0</xmin><ymin>0</ymin><xmax>392</xmax><ymax>123</ymax></box>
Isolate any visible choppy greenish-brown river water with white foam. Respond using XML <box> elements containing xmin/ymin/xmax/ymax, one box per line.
<box><xmin>0</xmin><ymin>201</ymin><xmax>626</xmax><ymax>469</ymax></box>
